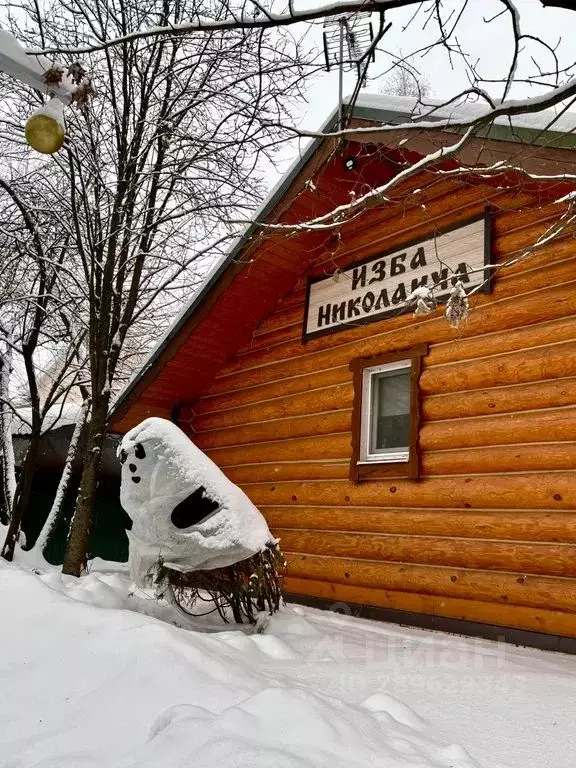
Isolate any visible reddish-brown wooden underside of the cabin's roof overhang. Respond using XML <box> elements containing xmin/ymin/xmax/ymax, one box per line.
<box><xmin>111</xmin><ymin>117</ymin><xmax>576</xmax><ymax>432</ymax></box>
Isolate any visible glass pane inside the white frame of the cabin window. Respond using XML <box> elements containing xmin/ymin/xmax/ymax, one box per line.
<box><xmin>370</xmin><ymin>368</ymin><xmax>410</xmax><ymax>453</ymax></box>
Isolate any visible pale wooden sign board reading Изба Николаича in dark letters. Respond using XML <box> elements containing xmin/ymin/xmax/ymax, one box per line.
<box><xmin>303</xmin><ymin>213</ymin><xmax>490</xmax><ymax>341</ymax></box>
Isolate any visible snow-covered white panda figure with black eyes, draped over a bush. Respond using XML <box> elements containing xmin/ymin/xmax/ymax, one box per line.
<box><xmin>118</xmin><ymin>418</ymin><xmax>274</xmax><ymax>587</ymax></box>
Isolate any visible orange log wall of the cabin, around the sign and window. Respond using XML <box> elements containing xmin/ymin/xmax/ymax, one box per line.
<box><xmin>190</xmin><ymin>195</ymin><xmax>576</xmax><ymax>637</ymax></box>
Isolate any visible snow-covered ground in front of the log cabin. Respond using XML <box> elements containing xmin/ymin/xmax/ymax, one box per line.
<box><xmin>0</xmin><ymin>563</ymin><xmax>576</xmax><ymax>768</ymax></box>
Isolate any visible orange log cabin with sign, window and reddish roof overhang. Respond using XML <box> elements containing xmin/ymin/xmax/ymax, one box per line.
<box><xmin>112</xmin><ymin>98</ymin><xmax>576</xmax><ymax>649</ymax></box>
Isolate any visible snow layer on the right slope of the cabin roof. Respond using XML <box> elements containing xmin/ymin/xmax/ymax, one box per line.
<box><xmin>354</xmin><ymin>93</ymin><xmax>576</xmax><ymax>133</ymax></box>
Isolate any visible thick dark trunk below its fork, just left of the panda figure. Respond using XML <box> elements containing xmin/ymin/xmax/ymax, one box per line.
<box><xmin>62</xmin><ymin>394</ymin><xmax>110</xmax><ymax>576</ymax></box>
